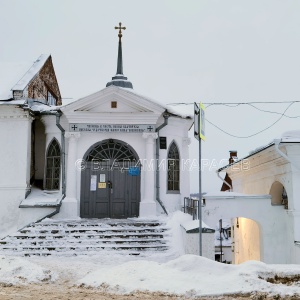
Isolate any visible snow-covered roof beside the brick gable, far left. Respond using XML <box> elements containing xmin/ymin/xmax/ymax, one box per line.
<box><xmin>0</xmin><ymin>54</ymin><xmax>50</xmax><ymax>100</ymax></box>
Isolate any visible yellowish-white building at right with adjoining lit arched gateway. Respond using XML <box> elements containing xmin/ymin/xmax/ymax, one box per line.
<box><xmin>203</xmin><ymin>130</ymin><xmax>300</xmax><ymax>263</ymax></box>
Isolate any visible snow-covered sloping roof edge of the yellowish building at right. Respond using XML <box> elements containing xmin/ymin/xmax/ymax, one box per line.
<box><xmin>218</xmin><ymin>130</ymin><xmax>300</xmax><ymax>172</ymax></box>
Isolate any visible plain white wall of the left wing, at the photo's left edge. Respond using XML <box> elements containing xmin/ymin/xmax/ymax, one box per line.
<box><xmin>0</xmin><ymin>105</ymin><xmax>54</xmax><ymax>238</ymax></box>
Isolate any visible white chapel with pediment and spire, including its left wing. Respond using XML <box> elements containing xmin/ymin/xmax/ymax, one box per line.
<box><xmin>0</xmin><ymin>26</ymin><xmax>193</xmax><ymax>238</ymax></box>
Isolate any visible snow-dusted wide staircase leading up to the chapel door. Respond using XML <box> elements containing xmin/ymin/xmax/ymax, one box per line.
<box><xmin>0</xmin><ymin>219</ymin><xmax>170</xmax><ymax>256</ymax></box>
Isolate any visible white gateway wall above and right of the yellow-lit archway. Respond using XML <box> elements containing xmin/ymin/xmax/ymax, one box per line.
<box><xmin>203</xmin><ymin>192</ymin><xmax>293</xmax><ymax>263</ymax></box>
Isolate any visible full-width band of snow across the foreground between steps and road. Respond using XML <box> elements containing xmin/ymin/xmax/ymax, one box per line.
<box><xmin>0</xmin><ymin>214</ymin><xmax>300</xmax><ymax>299</ymax></box>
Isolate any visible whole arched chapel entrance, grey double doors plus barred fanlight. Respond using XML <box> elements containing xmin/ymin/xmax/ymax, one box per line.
<box><xmin>80</xmin><ymin>139</ymin><xmax>140</xmax><ymax>218</ymax></box>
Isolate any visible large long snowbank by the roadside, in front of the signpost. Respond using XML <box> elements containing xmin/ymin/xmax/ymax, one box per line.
<box><xmin>79</xmin><ymin>255</ymin><xmax>300</xmax><ymax>297</ymax></box>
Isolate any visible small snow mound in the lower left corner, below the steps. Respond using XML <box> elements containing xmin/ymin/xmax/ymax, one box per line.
<box><xmin>0</xmin><ymin>255</ymin><xmax>56</xmax><ymax>285</ymax></box>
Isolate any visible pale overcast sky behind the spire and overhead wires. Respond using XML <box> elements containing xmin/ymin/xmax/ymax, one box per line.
<box><xmin>0</xmin><ymin>0</ymin><xmax>300</xmax><ymax>192</ymax></box>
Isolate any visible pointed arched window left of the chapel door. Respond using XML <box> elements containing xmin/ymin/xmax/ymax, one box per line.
<box><xmin>45</xmin><ymin>139</ymin><xmax>60</xmax><ymax>190</ymax></box>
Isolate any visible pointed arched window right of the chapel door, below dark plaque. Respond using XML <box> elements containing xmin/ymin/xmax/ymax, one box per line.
<box><xmin>168</xmin><ymin>142</ymin><xmax>180</xmax><ymax>191</ymax></box>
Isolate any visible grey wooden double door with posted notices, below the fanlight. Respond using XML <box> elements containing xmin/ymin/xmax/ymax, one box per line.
<box><xmin>80</xmin><ymin>162</ymin><xmax>140</xmax><ymax>219</ymax></box>
